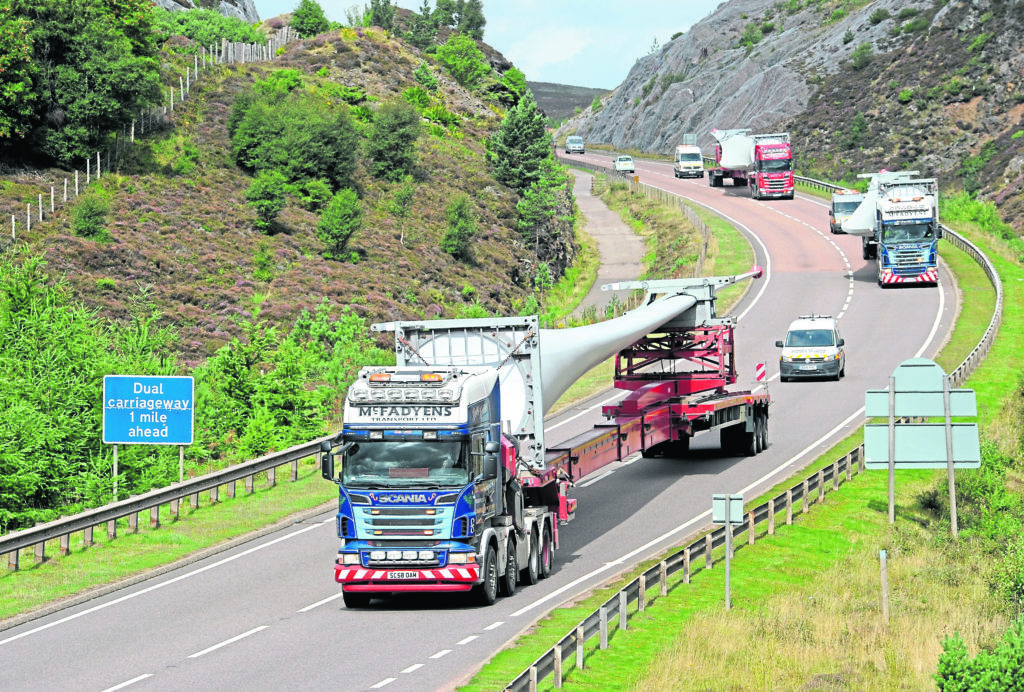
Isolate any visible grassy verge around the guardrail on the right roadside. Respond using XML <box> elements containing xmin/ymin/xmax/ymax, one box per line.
<box><xmin>461</xmin><ymin>198</ymin><xmax>1024</xmax><ymax>690</ymax></box>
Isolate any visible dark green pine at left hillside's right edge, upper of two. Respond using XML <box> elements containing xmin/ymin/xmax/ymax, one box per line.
<box><xmin>490</xmin><ymin>91</ymin><xmax>551</xmax><ymax>194</ymax></box>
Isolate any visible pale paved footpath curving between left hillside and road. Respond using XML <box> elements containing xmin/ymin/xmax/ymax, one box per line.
<box><xmin>571</xmin><ymin>169</ymin><xmax>646</xmax><ymax>317</ymax></box>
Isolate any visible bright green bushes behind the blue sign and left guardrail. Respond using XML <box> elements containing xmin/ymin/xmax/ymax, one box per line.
<box><xmin>0</xmin><ymin>251</ymin><xmax>393</xmax><ymax>533</ymax></box>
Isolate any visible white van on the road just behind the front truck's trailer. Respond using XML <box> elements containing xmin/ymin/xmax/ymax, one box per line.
<box><xmin>775</xmin><ymin>314</ymin><xmax>846</xmax><ymax>382</ymax></box>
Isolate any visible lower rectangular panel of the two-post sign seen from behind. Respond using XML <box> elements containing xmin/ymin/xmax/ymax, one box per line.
<box><xmin>864</xmin><ymin>423</ymin><xmax>981</xmax><ymax>471</ymax></box>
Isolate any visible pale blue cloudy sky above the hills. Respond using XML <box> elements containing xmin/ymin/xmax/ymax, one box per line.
<box><xmin>254</xmin><ymin>0</ymin><xmax>724</xmax><ymax>90</ymax></box>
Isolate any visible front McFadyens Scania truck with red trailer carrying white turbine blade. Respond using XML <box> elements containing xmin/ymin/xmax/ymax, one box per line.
<box><xmin>322</xmin><ymin>267</ymin><xmax>770</xmax><ymax>607</ymax></box>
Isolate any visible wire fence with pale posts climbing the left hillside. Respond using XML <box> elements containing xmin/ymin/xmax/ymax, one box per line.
<box><xmin>10</xmin><ymin>27</ymin><xmax>299</xmax><ymax>242</ymax></box>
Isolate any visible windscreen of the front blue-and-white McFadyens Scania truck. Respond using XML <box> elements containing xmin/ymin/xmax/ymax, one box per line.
<box><xmin>341</xmin><ymin>440</ymin><xmax>469</xmax><ymax>487</ymax></box>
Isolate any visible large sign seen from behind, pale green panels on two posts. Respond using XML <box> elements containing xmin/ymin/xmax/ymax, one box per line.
<box><xmin>864</xmin><ymin>358</ymin><xmax>981</xmax><ymax>538</ymax></box>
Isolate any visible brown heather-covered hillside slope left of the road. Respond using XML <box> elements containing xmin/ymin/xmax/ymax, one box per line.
<box><xmin>0</xmin><ymin>30</ymin><xmax>575</xmax><ymax>363</ymax></box>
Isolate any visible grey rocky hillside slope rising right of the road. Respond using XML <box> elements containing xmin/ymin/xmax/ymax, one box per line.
<box><xmin>557</xmin><ymin>0</ymin><xmax>1024</xmax><ymax>233</ymax></box>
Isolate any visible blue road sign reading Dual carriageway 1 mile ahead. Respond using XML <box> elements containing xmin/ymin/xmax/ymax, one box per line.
<box><xmin>103</xmin><ymin>375</ymin><xmax>196</xmax><ymax>444</ymax></box>
